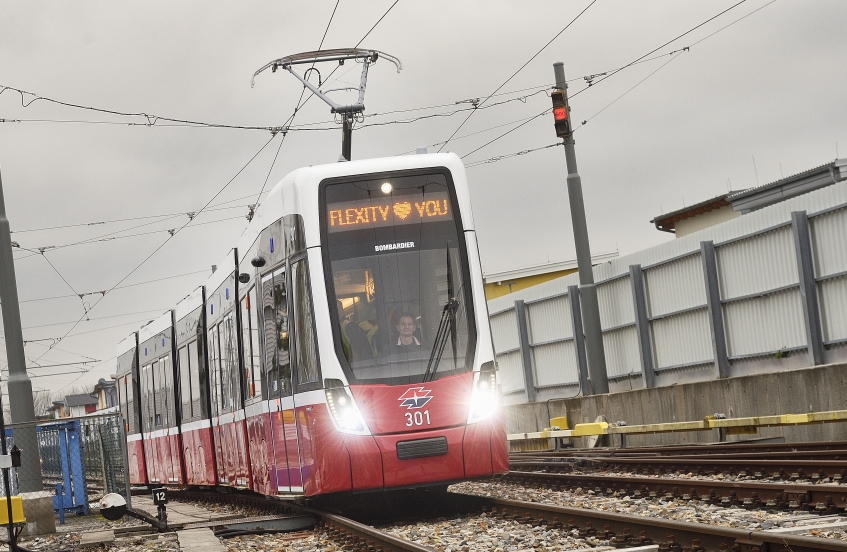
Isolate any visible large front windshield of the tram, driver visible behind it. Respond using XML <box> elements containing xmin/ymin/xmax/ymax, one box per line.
<box><xmin>324</xmin><ymin>173</ymin><xmax>476</xmax><ymax>385</ymax></box>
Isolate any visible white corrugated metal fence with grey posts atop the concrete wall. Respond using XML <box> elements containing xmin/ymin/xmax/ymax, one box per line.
<box><xmin>488</xmin><ymin>182</ymin><xmax>847</xmax><ymax>404</ymax></box>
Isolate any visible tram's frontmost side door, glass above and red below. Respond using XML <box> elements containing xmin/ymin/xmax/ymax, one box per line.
<box><xmin>262</xmin><ymin>265</ymin><xmax>303</xmax><ymax>493</ymax></box>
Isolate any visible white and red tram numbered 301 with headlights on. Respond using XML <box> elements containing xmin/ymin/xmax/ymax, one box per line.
<box><xmin>116</xmin><ymin>154</ymin><xmax>508</xmax><ymax>496</ymax></box>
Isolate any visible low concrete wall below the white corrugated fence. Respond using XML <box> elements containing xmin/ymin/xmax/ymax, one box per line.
<box><xmin>505</xmin><ymin>363</ymin><xmax>847</xmax><ymax>446</ymax></box>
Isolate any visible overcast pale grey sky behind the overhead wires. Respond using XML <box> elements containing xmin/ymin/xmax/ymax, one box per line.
<box><xmin>0</xmin><ymin>0</ymin><xmax>847</xmax><ymax>400</ymax></box>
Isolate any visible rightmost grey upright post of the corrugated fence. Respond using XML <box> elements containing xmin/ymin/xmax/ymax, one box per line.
<box><xmin>791</xmin><ymin>211</ymin><xmax>824</xmax><ymax>366</ymax></box>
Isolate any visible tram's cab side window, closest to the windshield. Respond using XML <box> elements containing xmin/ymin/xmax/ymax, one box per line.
<box><xmin>291</xmin><ymin>259</ymin><xmax>320</xmax><ymax>385</ymax></box>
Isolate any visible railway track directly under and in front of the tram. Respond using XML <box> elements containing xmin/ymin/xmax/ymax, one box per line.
<box><xmin>172</xmin><ymin>491</ymin><xmax>847</xmax><ymax>552</ymax></box>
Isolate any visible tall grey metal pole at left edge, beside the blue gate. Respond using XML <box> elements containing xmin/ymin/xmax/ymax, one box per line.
<box><xmin>0</xmin><ymin>165</ymin><xmax>44</xmax><ymax>492</ymax></box>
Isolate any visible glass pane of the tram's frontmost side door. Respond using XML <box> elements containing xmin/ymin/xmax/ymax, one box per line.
<box><xmin>262</xmin><ymin>268</ymin><xmax>292</xmax><ymax>398</ymax></box>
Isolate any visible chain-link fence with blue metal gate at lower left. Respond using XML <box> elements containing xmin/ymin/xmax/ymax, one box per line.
<box><xmin>0</xmin><ymin>414</ymin><xmax>130</xmax><ymax>538</ymax></box>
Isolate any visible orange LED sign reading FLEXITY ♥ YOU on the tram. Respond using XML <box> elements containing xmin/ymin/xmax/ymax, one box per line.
<box><xmin>327</xmin><ymin>192</ymin><xmax>453</xmax><ymax>232</ymax></box>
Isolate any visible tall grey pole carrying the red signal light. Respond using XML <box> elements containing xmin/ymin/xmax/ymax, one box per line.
<box><xmin>553</xmin><ymin>62</ymin><xmax>609</xmax><ymax>394</ymax></box>
